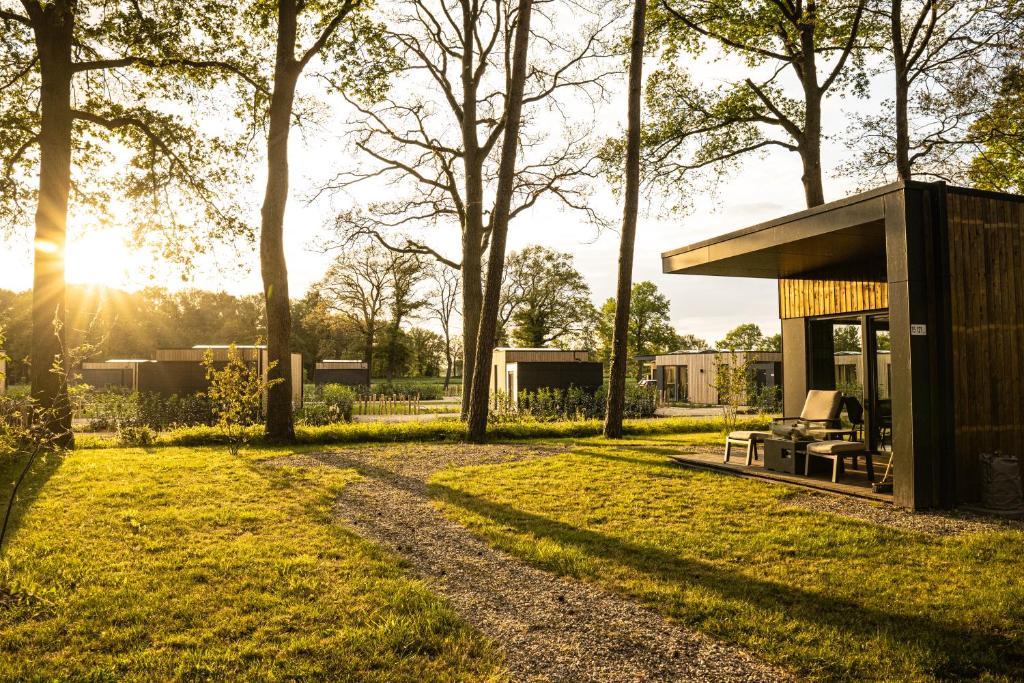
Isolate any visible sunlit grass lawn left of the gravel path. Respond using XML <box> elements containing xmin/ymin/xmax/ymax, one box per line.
<box><xmin>0</xmin><ymin>447</ymin><xmax>503</xmax><ymax>681</ymax></box>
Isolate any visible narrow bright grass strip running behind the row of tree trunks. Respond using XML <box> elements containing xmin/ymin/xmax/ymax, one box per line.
<box><xmin>75</xmin><ymin>418</ymin><xmax>769</xmax><ymax>449</ymax></box>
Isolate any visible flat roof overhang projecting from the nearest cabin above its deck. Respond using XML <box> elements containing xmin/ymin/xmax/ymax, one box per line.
<box><xmin>662</xmin><ymin>183</ymin><xmax>905</xmax><ymax>279</ymax></box>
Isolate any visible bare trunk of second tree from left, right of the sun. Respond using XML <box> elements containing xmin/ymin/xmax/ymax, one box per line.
<box><xmin>260</xmin><ymin>0</ymin><xmax>299</xmax><ymax>443</ymax></box>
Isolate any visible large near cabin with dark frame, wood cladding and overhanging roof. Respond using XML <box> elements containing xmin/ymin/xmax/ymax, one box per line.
<box><xmin>662</xmin><ymin>182</ymin><xmax>1024</xmax><ymax>508</ymax></box>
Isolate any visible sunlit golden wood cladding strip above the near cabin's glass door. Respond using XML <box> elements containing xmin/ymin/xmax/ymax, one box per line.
<box><xmin>778</xmin><ymin>279</ymin><xmax>889</xmax><ymax>319</ymax></box>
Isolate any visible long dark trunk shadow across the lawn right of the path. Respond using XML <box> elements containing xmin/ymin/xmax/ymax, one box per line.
<box><xmin>425</xmin><ymin>473</ymin><xmax>1024</xmax><ymax>678</ymax></box>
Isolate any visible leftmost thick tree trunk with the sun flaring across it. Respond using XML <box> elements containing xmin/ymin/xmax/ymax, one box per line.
<box><xmin>30</xmin><ymin>2</ymin><xmax>75</xmax><ymax>446</ymax></box>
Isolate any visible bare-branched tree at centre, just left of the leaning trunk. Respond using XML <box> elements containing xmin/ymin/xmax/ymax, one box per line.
<box><xmin>328</xmin><ymin>0</ymin><xmax>613</xmax><ymax>414</ymax></box>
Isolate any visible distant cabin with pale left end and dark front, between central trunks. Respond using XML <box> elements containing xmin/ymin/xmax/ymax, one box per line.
<box><xmin>490</xmin><ymin>347</ymin><xmax>604</xmax><ymax>400</ymax></box>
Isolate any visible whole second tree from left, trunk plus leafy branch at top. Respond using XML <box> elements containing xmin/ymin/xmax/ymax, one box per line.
<box><xmin>256</xmin><ymin>0</ymin><xmax>390</xmax><ymax>441</ymax></box>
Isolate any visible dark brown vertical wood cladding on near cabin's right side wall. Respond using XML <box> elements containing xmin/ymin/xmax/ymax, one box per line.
<box><xmin>946</xmin><ymin>189</ymin><xmax>1024</xmax><ymax>500</ymax></box>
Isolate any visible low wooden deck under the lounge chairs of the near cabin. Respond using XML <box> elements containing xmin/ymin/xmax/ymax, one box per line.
<box><xmin>670</xmin><ymin>445</ymin><xmax>893</xmax><ymax>504</ymax></box>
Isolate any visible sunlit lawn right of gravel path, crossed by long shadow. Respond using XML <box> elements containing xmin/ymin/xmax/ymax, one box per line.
<box><xmin>432</xmin><ymin>434</ymin><xmax>1024</xmax><ymax>681</ymax></box>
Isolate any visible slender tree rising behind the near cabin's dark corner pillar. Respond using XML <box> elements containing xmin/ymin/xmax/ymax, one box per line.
<box><xmin>856</xmin><ymin>0</ymin><xmax>1021</xmax><ymax>183</ymax></box>
